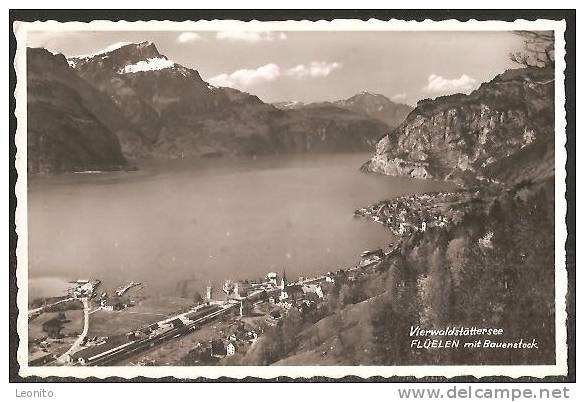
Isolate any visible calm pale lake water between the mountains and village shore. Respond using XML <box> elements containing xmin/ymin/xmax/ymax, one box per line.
<box><xmin>28</xmin><ymin>154</ymin><xmax>454</xmax><ymax>297</ymax></box>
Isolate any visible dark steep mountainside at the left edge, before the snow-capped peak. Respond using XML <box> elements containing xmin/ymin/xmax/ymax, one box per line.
<box><xmin>27</xmin><ymin>49</ymin><xmax>134</xmax><ymax>173</ymax></box>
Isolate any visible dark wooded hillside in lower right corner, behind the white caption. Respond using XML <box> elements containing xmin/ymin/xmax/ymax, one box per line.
<box><xmin>240</xmin><ymin>179</ymin><xmax>555</xmax><ymax>366</ymax></box>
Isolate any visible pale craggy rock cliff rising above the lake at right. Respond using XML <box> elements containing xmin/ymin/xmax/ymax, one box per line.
<box><xmin>362</xmin><ymin>68</ymin><xmax>554</xmax><ymax>182</ymax></box>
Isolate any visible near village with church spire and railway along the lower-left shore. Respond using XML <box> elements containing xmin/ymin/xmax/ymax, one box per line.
<box><xmin>29</xmin><ymin>245</ymin><xmax>398</xmax><ymax>366</ymax></box>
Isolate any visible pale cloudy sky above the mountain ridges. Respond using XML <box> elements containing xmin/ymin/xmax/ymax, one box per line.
<box><xmin>28</xmin><ymin>31</ymin><xmax>523</xmax><ymax>105</ymax></box>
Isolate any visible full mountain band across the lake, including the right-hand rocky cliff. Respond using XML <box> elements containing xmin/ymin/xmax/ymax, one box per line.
<box><xmin>27</xmin><ymin>42</ymin><xmax>554</xmax><ymax>182</ymax></box>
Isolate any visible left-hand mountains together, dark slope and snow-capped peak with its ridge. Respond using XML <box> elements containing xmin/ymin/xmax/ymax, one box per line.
<box><xmin>27</xmin><ymin>42</ymin><xmax>389</xmax><ymax>173</ymax></box>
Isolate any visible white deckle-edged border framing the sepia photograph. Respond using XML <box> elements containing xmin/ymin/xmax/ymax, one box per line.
<box><xmin>13</xmin><ymin>19</ymin><xmax>568</xmax><ymax>379</ymax></box>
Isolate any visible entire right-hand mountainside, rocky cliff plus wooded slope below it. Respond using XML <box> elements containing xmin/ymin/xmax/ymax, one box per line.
<box><xmin>238</xmin><ymin>69</ymin><xmax>555</xmax><ymax>366</ymax></box>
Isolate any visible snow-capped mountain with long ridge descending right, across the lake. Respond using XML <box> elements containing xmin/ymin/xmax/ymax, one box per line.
<box><xmin>69</xmin><ymin>42</ymin><xmax>388</xmax><ymax>159</ymax></box>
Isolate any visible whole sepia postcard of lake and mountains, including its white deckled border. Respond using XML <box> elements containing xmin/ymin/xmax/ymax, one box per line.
<box><xmin>13</xmin><ymin>15</ymin><xmax>568</xmax><ymax>379</ymax></box>
